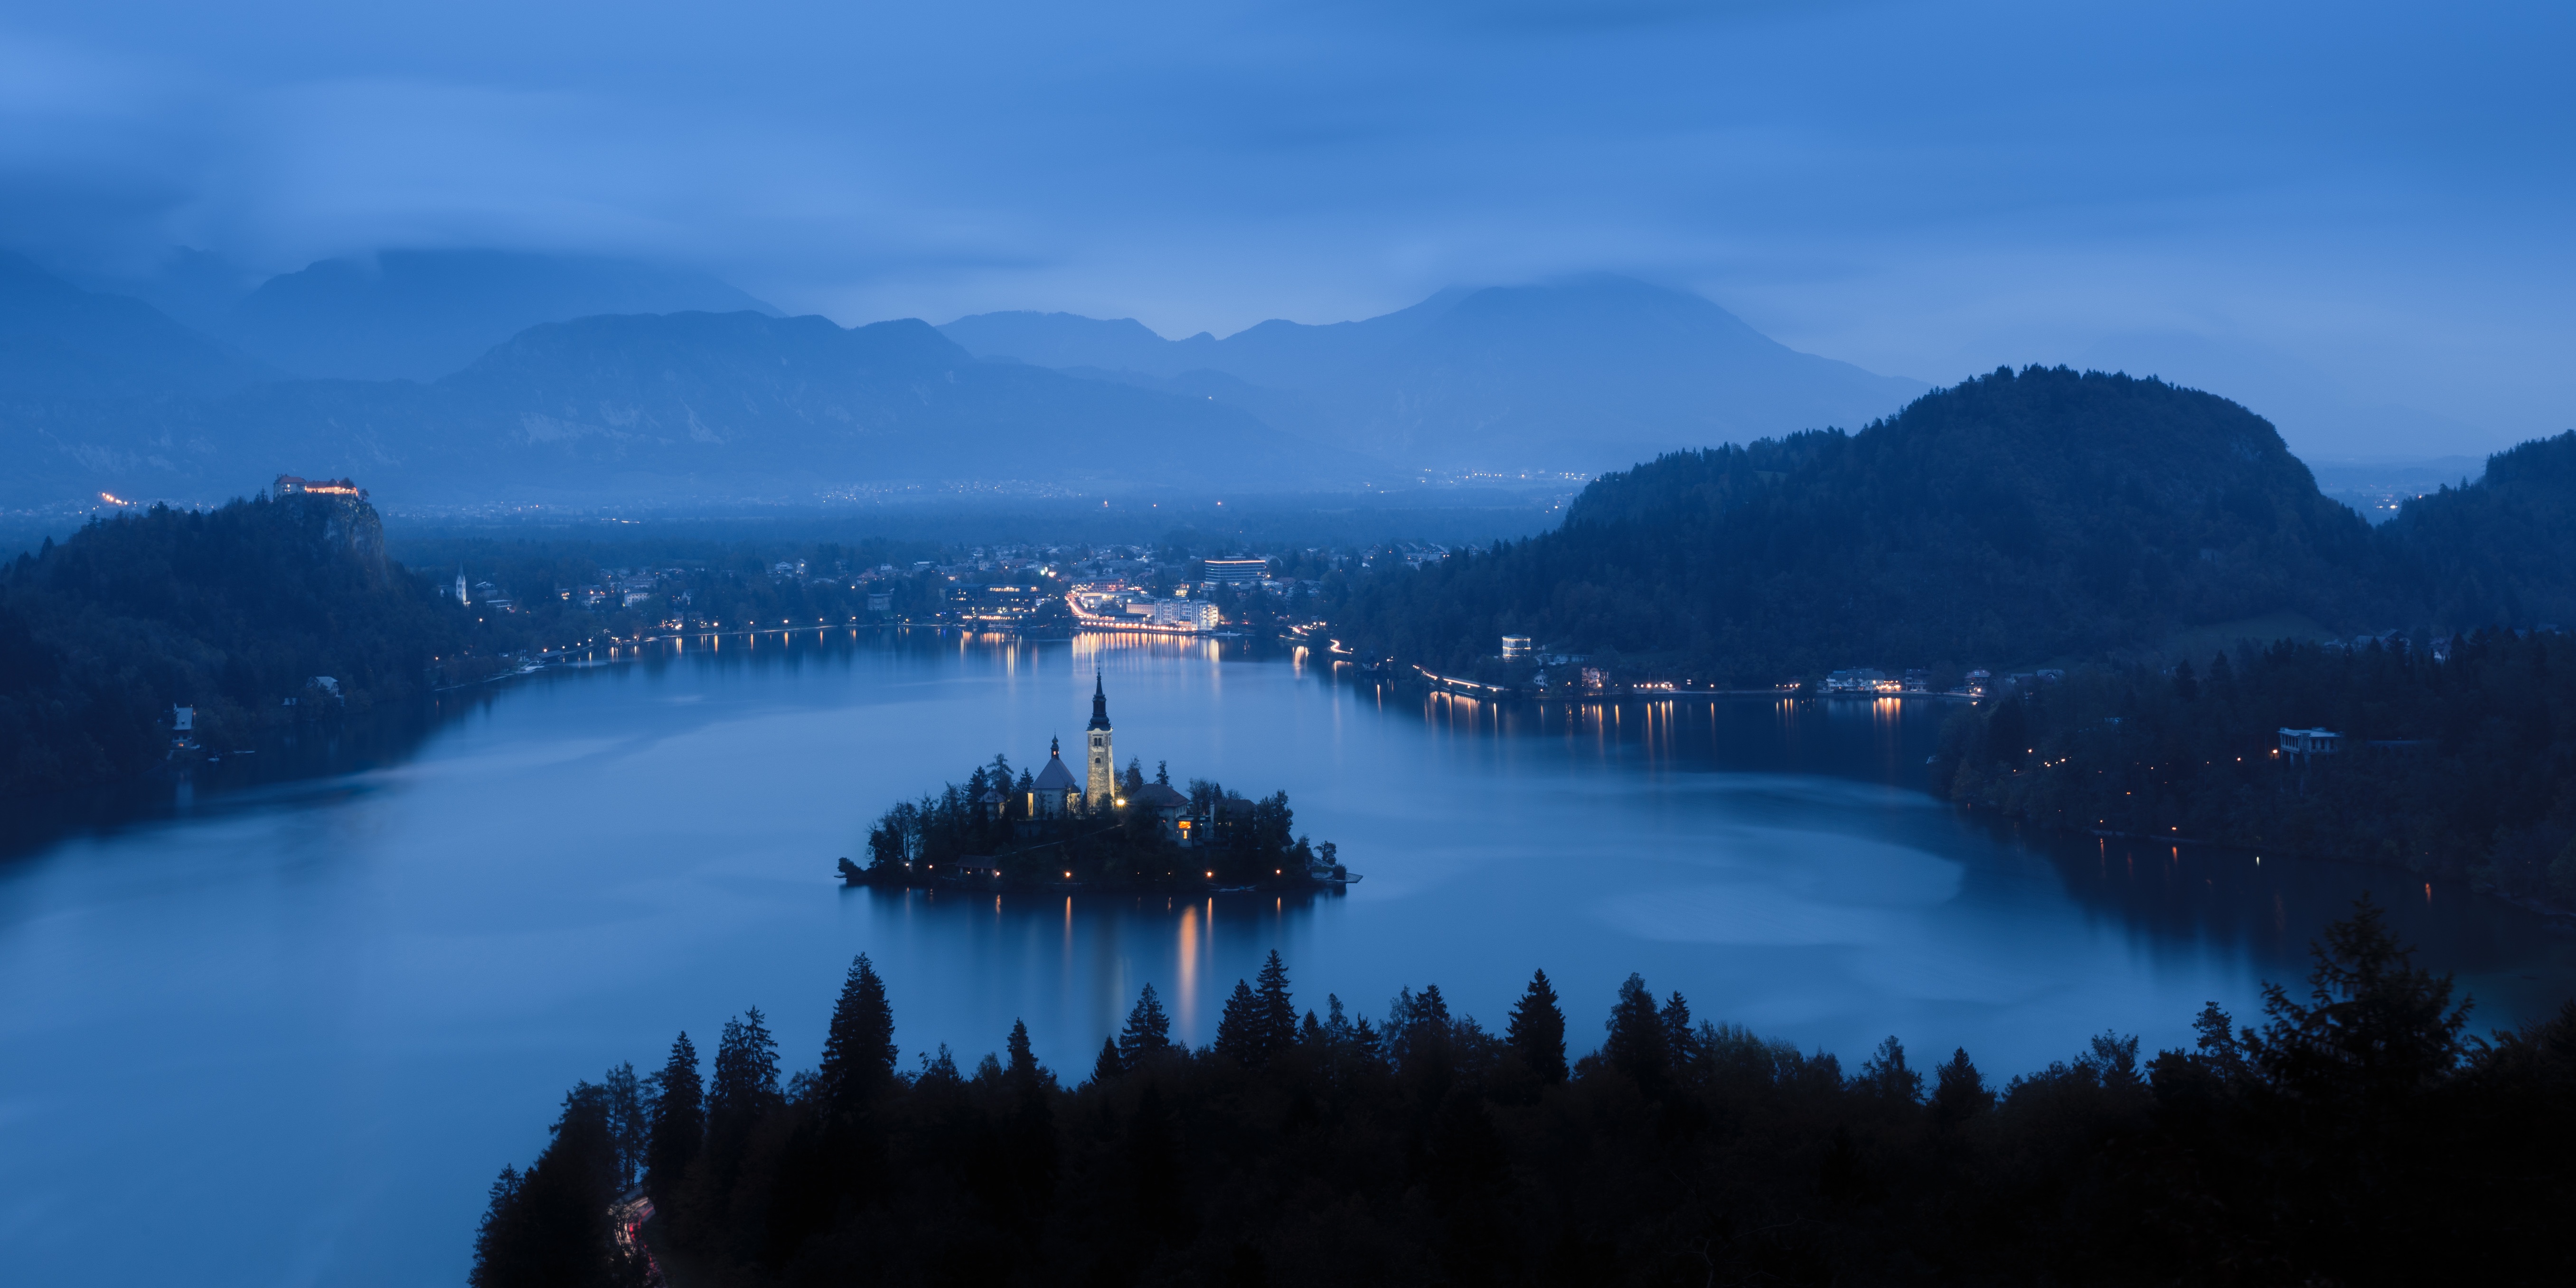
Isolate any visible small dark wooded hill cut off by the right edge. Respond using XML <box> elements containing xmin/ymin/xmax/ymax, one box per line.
<box><xmin>2378</xmin><ymin>430</ymin><xmax>2576</xmax><ymax>626</ymax></box>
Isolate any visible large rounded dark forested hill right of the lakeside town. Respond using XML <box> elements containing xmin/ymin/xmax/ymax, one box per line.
<box><xmin>1335</xmin><ymin>368</ymin><xmax>2390</xmax><ymax>685</ymax></box>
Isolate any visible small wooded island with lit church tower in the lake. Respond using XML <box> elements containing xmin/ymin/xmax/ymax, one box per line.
<box><xmin>840</xmin><ymin>675</ymin><xmax>1358</xmax><ymax>891</ymax></box>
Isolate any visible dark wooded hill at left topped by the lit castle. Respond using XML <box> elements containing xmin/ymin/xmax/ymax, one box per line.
<box><xmin>0</xmin><ymin>495</ymin><xmax>466</xmax><ymax>796</ymax></box>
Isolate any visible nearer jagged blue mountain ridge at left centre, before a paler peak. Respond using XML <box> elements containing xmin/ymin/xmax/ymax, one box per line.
<box><xmin>211</xmin><ymin>312</ymin><xmax>1363</xmax><ymax>500</ymax></box>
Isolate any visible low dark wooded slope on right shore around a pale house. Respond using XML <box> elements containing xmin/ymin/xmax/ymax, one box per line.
<box><xmin>1932</xmin><ymin>631</ymin><xmax>2576</xmax><ymax>912</ymax></box>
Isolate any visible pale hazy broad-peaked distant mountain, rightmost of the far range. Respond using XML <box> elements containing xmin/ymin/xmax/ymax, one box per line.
<box><xmin>940</xmin><ymin>276</ymin><xmax>1929</xmax><ymax>474</ymax></box>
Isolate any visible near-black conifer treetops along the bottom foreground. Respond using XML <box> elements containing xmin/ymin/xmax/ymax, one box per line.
<box><xmin>474</xmin><ymin>902</ymin><xmax>2576</xmax><ymax>1288</ymax></box>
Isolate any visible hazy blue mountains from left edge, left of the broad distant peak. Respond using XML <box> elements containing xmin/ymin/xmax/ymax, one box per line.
<box><xmin>0</xmin><ymin>255</ymin><xmax>1389</xmax><ymax>508</ymax></box>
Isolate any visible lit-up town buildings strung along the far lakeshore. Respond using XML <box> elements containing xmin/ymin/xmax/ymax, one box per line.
<box><xmin>376</xmin><ymin>502</ymin><xmax>2153</xmax><ymax>701</ymax></box>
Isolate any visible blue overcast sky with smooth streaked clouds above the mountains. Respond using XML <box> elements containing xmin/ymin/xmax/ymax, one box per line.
<box><xmin>0</xmin><ymin>0</ymin><xmax>2576</xmax><ymax>456</ymax></box>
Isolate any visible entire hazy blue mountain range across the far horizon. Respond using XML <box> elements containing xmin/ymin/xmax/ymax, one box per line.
<box><xmin>0</xmin><ymin>253</ymin><xmax>1922</xmax><ymax>505</ymax></box>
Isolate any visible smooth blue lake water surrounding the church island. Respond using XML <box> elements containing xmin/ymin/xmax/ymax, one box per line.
<box><xmin>0</xmin><ymin>634</ymin><xmax>2576</xmax><ymax>1286</ymax></box>
